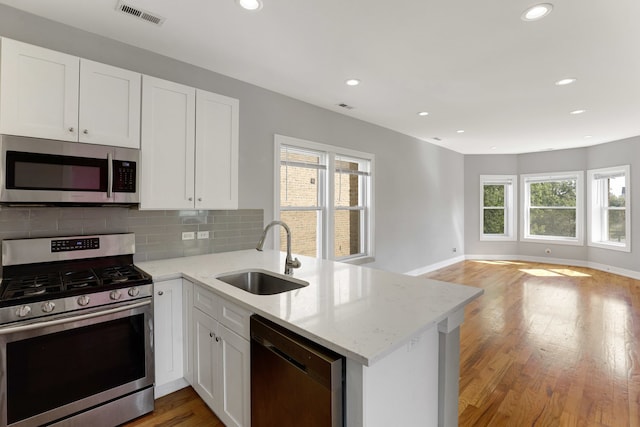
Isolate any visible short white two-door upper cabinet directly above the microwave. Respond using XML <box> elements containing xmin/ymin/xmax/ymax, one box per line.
<box><xmin>0</xmin><ymin>38</ymin><xmax>141</xmax><ymax>148</ymax></box>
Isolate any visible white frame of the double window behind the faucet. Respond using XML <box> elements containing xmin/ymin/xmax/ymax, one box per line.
<box><xmin>273</xmin><ymin>134</ymin><xmax>375</xmax><ymax>263</ymax></box>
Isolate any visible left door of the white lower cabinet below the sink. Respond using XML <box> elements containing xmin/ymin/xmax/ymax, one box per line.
<box><xmin>192</xmin><ymin>309</ymin><xmax>221</xmax><ymax>411</ymax></box>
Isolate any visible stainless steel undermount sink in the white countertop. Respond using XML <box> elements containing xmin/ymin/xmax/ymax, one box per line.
<box><xmin>216</xmin><ymin>270</ymin><xmax>309</xmax><ymax>295</ymax></box>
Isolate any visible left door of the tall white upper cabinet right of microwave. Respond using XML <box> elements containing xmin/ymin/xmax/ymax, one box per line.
<box><xmin>140</xmin><ymin>76</ymin><xmax>196</xmax><ymax>209</ymax></box>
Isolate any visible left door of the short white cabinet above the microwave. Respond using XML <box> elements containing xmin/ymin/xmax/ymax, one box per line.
<box><xmin>0</xmin><ymin>38</ymin><xmax>80</xmax><ymax>141</ymax></box>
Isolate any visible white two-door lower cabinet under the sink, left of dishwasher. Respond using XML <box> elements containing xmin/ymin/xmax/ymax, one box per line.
<box><xmin>191</xmin><ymin>285</ymin><xmax>251</xmax><ymax>427</ymax></box>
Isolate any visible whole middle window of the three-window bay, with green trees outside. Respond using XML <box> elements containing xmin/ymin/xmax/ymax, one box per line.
<box><xmin>522</xmin><ymin>171</ymin><xmax>584</xmax><ymax>245</ymax></box>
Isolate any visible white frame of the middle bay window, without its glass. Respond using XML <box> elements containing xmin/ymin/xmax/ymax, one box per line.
<box><xmin>520</xmin><ymin>171</ymin><xmax>585</xmax><ymax>246</ymax></box>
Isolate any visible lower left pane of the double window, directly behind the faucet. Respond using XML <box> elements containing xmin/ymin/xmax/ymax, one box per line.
<box><xmin>280</xmin><ymin>211</ymin><xmax>320</xmax><ymax>257</ymax></box>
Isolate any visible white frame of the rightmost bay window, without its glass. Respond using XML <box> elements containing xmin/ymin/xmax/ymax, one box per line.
<box><xmin>587</xmin><ymin>165</ymin><xmax>631</xmax><ymax>252</ymax></box>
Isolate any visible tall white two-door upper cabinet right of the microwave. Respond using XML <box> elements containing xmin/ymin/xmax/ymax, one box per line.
<box><xmin>140</xmin><ymin>76</ymin><xmax>239</xmax><ymax>209</ymax></box>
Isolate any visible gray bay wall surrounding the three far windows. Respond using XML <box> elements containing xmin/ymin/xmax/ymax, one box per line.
<box><xmin>464</xmin><ymin>137</ymin><xmax>640</xmax><ymax>271</ymax></box>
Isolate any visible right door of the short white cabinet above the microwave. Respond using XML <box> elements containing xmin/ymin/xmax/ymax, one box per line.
<box><xmin>79</xmin><ymin>59</ymin><xmax>142</xmax><ymax>148</ymax></box>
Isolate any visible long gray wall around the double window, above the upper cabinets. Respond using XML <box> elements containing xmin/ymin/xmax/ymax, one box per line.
<box><xmin>0</xmin><ymin>5</ymin><xmax>464</xmax><ymax>272</ymax></box>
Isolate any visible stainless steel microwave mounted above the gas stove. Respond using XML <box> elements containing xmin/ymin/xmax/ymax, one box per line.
<box><xmin>0</xmin><ymin>135</ymin><xmax>140</xmax><ymax>205</ymax></box>
